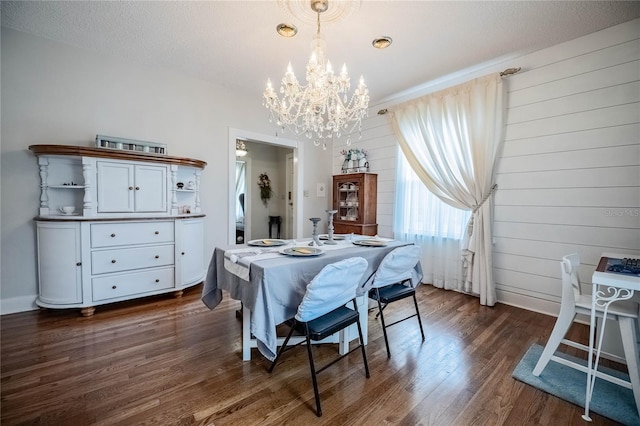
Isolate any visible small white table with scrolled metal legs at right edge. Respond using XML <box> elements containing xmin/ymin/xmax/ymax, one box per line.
<box><xmin>582</xmin><ymin>252</ymin><xmax>640</xmax><ymax>421</ymax></box>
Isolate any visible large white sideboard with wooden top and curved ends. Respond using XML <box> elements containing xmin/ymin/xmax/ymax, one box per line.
<box><xmin>29</xmin><ymin>145</ymin><xmax>206</xmax><ymax>316</ymax></box>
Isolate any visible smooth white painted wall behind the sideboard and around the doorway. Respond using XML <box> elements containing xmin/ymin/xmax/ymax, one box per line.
<box><xmin>0</xmin><ymin>28</ymin><xmax>331</xmax><ymax>314</ymax></box>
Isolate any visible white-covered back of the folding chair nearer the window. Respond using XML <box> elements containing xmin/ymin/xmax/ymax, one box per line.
<box><xmin>365</xmin><ymin>245</ymin><xmax>422</xmax><ymax>291</ymax></box>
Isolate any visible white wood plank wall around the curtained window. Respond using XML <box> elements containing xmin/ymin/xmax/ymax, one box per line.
<box><xmin>334</xmin><ymin>20</ymin><xmax>640</xmax><ymax>315</ymax></box>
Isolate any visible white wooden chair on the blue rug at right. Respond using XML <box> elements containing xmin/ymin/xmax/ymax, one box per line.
<box><xmin>533</xmin><ymin>253</ymin><xmax>640</xmax><ymax>409</ymax></box>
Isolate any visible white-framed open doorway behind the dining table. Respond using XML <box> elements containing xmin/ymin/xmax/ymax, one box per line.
<box><xmin>228</xmin><ymin>129</ymin><xmax>303</xmax><ymax>244</ymax></box>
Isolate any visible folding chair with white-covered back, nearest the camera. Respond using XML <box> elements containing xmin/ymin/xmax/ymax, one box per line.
<box><xmin>269</xmin><ymin>257</ymin><xmax>369</xmax><ymax>417</ymax></box>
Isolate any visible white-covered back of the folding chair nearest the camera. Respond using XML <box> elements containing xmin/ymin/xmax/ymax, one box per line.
<box><xmin>295</xmin><ymin>257</ymin><xmax>368</xmax><ymax>322</ymax></box>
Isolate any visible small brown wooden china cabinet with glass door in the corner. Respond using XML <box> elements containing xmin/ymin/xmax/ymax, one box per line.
<box><xmin>333</xmin><ymin>173</ymin><xmax>378</xmax><ymax>235</ymax></box>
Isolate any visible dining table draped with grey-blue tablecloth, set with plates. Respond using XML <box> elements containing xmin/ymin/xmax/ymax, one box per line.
<box><xmin>201</xmin><ymin>235</ymin><xmax>422</xmax><ymax>361</ymax></box>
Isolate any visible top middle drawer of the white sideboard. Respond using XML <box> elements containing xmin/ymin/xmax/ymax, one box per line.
<box><xmin>91</xmin><ymin>221</ymin><xmax>174</xmax><ymax>248</ymax></box>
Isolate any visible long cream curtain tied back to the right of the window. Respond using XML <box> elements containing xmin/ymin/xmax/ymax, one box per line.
<box><xmin>392</xmin><ymin>75</ymin><xmax>506</xmax><ymax>306</ymax></box>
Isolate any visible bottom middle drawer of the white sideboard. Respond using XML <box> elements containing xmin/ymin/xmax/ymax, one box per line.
<box><xmin>91</xmin><ymin>268</ymin><xmax>174</xmax><ymax>302</ymax></box>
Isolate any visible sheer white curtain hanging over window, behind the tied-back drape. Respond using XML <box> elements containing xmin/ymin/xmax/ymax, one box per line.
<box><xmin>393</xmin><ymin>151</ymin><xmax>471</xmax><ymax>291</ymax></box>
